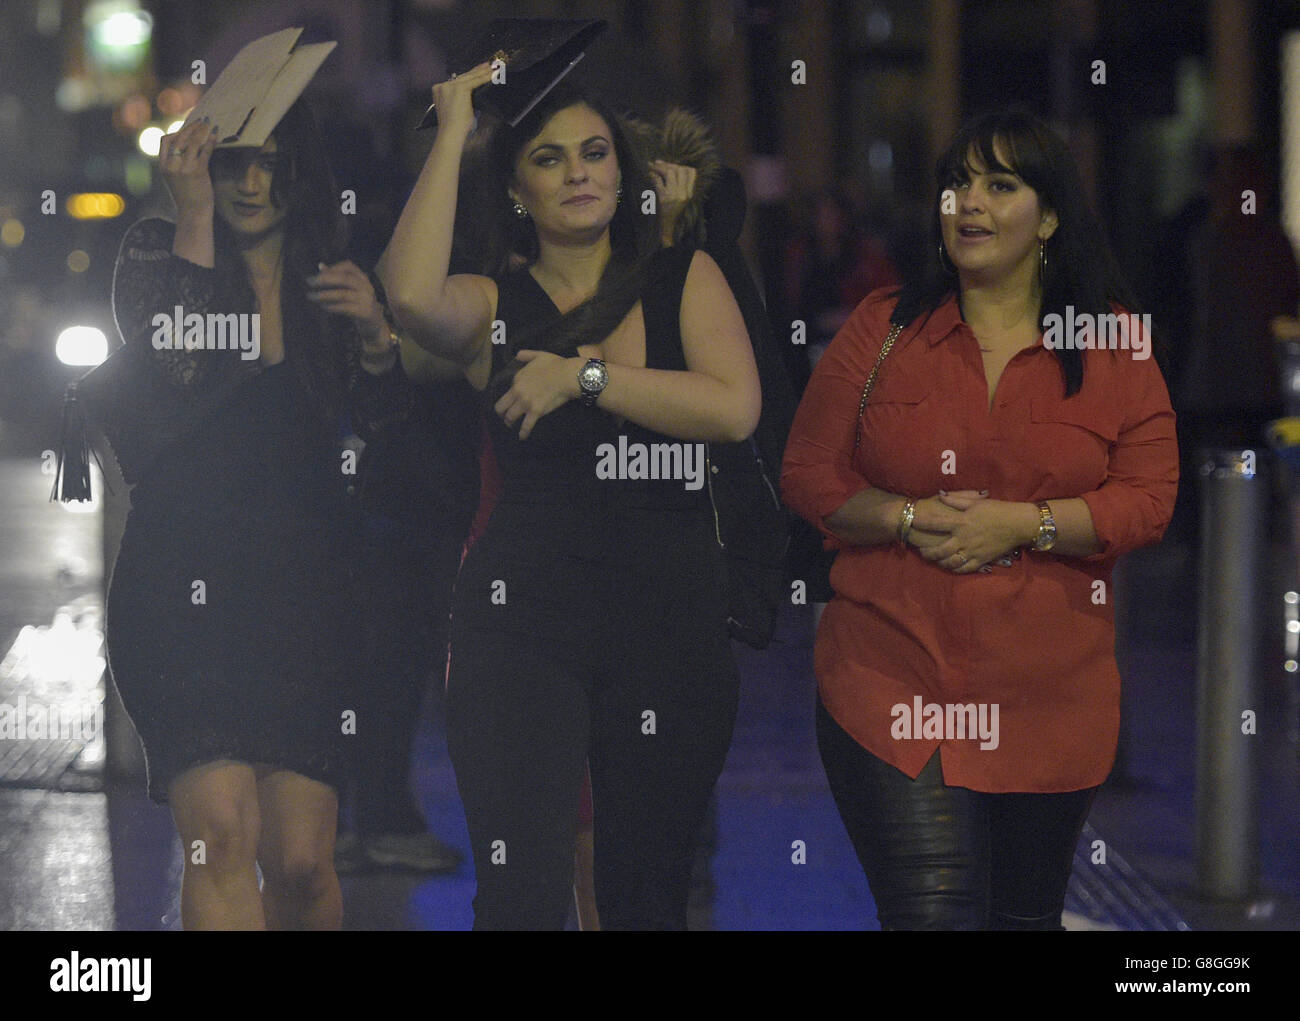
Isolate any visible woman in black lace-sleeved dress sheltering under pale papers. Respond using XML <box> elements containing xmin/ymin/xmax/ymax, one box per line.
<box><xmin>107</xmin><ymin>101</ymin><xmax>408</xmax><ymax>929</ymax></box>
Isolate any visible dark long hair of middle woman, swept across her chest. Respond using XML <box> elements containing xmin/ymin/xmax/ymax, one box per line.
<box><xmin>475</xmin><ymin>82</ymin><xmax>659</xmax><ymax>393</ymax></box>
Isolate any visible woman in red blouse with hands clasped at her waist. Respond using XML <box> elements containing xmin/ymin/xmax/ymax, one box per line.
<box><xmin>781</xmin><ymin>112</ymin><xmax>1178</xmax><ymax>929</ymax></box>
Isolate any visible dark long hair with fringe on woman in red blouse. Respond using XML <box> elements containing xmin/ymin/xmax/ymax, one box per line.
<box><xmin>892</xmin><ymin>108</ymin><xmax>1139</xmax><ymax>397</ymax></box>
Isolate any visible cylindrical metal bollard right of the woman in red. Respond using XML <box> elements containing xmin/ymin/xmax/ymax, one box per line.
<box><xmin>1196</xmin><ymin>450</ymin><xmax>1268</xmax><ymax>900</ymax></box>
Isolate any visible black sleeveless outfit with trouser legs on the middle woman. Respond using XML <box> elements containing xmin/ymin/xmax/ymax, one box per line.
<box><xmin>447</xmin><ymin>250</ymin><xmax>738</xmax><ymax>929</ymax></box>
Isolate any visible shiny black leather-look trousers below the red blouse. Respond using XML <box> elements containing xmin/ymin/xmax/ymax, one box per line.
<box><xmin>816</xmin><ymin>698</ymin><xmax>1097</xmax><ymax>930</ymax></box>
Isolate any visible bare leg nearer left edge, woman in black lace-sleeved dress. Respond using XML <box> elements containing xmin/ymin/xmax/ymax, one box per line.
<box><xmin>168</xmin><ymin>760</ymin><xmax>267</xmax><ymax>930</ymax></box>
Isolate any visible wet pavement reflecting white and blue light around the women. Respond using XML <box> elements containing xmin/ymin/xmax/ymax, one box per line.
<box><xmin>0</xmin><ymin>458</ymin><xmax>1300</xmax><ymax>930</ymax></box>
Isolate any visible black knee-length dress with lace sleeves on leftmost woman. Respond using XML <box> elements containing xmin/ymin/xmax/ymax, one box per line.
<box><xmin>107</xmin><ymin>220</ymin><xmax>406</xmax><ymax>802</ymax></box>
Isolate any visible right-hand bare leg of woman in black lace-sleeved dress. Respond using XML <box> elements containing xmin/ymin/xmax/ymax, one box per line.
<box><xmin>257</xmin><ymin>766</ymin><xmax>343</xmax><ymax>929</ymax></box>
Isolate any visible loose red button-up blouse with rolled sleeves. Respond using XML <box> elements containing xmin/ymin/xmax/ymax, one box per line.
<box><xmin>781</xmin><ymin>291</ymin><xmax>1178</xmax><ymax>792</ymax></box>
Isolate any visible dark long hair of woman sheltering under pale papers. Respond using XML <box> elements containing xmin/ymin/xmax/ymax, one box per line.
<box><xmin>212</xmin><ymin>99</ymin><xmax>350</xmax><ymax>420</ymax></box>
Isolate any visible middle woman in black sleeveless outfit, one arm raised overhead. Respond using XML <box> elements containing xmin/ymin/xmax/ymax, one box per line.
<box><xmin>378</xmin><ymin>64</ymin><xmax>759</xmax><ymax>929</ymax></box>
